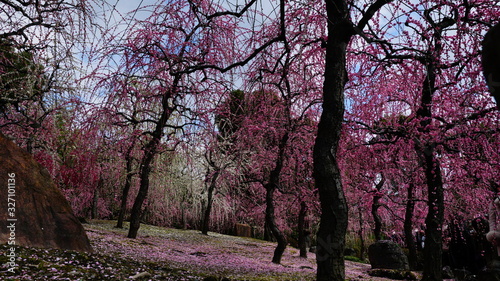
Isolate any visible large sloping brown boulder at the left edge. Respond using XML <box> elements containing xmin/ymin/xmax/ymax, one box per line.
<box><xmin>0</xmin><ymin>134</ymin><xmax>92</xmax><ymax>252</ymax></box>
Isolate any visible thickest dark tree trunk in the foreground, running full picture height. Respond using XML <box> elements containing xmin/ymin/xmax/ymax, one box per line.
<box><xmin>313</xmin><ymin>0</ymin><xmax>353</xmax><ymax>281</ymax></box>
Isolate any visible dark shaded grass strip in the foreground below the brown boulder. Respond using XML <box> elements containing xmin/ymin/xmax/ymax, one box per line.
<box><xmin>0</xmin><ymin>245</ymin><xmax>202</xmax><ymax>281</ymax></box>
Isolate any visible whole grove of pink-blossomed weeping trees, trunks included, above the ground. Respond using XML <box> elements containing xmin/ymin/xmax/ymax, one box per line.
<box><xmin>0</xmin><ymin>0</ymin><xmax>500</xmax><ymax>281</ymax></box>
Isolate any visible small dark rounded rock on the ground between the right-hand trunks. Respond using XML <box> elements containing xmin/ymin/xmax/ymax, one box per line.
<box><xmin>368</xmin><ymin>240</ymin><xmax>410</xmax><ymax>270</ymax></box>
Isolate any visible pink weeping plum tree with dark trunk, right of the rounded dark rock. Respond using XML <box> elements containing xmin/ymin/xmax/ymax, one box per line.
<box><xmin>346</xmin><ymin>1</ymin><xmax>494</xmax><ymax>280</ymax></box>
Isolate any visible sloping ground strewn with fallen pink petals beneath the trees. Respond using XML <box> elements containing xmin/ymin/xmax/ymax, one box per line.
<box><xmin>0</xmin><ymin>221</ymin><xmax>398</xmax><ymax>281</ymax></box>
